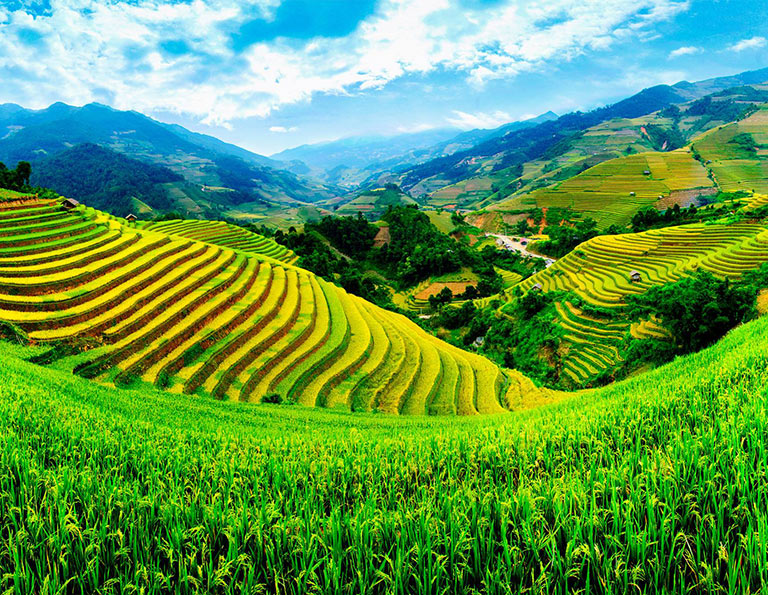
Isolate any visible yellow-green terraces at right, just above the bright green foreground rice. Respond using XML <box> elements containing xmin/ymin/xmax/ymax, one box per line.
<box><xmin>496</xmin><ymin>223</ymin><xmax>768</xmax><ymax>385</ymax></box>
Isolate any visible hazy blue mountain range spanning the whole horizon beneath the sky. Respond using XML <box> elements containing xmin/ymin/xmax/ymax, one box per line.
<box><xmin>0</xmin><ymin>68</ymin><xmax>768</xmax><ymax>226</ymax></box>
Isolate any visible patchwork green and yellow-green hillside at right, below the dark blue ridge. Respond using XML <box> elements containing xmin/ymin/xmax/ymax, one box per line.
<box><xmin>476</xmin><ymin>87</ymin><xmax>768</xmax><ymax>228</ymax></box>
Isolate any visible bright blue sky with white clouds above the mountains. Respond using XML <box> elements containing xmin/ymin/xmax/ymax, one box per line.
<box><xmin>0</xmin><ymin>0</ymin><xmax>768</xmax><ymax>155</ymax></box>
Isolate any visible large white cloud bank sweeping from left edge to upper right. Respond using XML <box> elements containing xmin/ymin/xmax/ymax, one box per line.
<box><xmin>0</xmin><ymin>0</ymin><xmax>688</xmax><ymax>125</ymax></box>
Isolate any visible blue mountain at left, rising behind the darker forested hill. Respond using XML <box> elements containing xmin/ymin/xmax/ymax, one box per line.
<box><xmin>0</xmin><ymin>103</ymin><xmax>337</xmax><ymax>218</ymax></box>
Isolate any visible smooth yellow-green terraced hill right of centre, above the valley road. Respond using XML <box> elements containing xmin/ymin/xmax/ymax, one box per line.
<box><xmin>489</xmin><ymin>150</ymin><xmax>714</xmax><ymax>228</ymax></box>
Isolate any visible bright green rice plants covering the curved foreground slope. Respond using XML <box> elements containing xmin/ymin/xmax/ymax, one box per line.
<box><xmin>0</xmin><ymin>310</ymin><xmax>768</xmax><ymax>594</ymax></box>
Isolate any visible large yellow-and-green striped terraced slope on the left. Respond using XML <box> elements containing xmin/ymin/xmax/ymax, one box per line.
<box><xmin>0</xmin><ymin>200</ymin><xmax>532</xmax><ymax>414</ymax></box>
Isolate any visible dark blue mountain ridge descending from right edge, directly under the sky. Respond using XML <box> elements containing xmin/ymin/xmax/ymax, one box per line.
<box><xmin>392</xmin><ymin>69</ymin><xmax>768</xmax><ymax>204</ymax></box>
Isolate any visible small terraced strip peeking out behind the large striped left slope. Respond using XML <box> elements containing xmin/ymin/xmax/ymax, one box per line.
<box><xmin>142</xmin><ymin>219</ymin><xmax>299</xmax><ymax>264</ymax></box>
